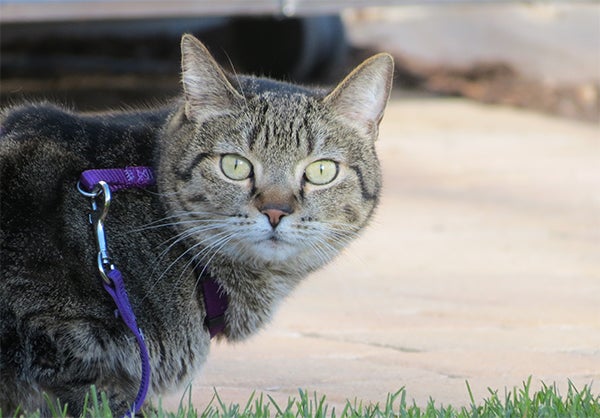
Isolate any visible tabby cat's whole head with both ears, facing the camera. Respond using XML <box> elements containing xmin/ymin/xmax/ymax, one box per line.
<box><xmin>158</xmin><ymin>35</ymin><xmax>393</xmax><ymax>272</ymax></box>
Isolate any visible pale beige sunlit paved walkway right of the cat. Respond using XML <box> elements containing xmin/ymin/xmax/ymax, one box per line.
<box><xmin>161</xmin><ymin>98</ymin><xmax>600</xmax><ymax>408</ymax></box>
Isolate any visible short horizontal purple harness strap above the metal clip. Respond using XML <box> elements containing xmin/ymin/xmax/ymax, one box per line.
<box><xmin>79</xmin><ymin>167</ymin><xmax>156</xmax><ymax>192</ymax></box>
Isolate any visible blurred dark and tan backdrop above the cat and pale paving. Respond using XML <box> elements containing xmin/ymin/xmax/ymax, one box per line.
<box><xmin>0</xmin><ymin>0</ymin><xmax>600</xmax><ymax>122</ymax></box>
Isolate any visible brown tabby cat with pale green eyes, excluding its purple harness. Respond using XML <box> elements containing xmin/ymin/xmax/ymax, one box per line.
<box><xmin>0</xmin><ymin>35</ymin><xmax>393</xmax><ymax>416</ymax></box>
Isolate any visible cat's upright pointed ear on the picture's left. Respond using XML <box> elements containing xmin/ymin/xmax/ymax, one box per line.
<box><xmin>181</xmin><ymin>34</ymin><xmax>243</xmax><ymax>120</ymax></box>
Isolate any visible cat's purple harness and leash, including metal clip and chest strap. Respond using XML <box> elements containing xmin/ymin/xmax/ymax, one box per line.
<box><xmin>77</xmin><ymin>167</ymin><xmax>228</xmax><ymax>416</ymax></box>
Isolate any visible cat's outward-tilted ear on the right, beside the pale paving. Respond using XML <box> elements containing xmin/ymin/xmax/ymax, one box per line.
<box><xmin>324</xmin><ymin>53</ymin><xmax>394</xmax><ymax>139</ymax></box>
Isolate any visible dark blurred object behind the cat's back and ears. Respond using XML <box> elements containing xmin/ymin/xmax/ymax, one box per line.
<box><xmin>0</xmin><ymin>15</ymin><xmax>348</xmax><ymax>109</ymax></box>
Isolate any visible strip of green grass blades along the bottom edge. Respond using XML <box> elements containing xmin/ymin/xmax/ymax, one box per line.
<box><xmin>5</xmin><ymin>378</ymin><xmax>600</xmax><ymax>418</ymax></box>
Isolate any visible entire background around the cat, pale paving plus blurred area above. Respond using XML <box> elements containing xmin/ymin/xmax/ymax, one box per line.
<box><xmin>0</xmin><ymin>0</ymin><xmax>600</xmax><ymax>408</ymax></box>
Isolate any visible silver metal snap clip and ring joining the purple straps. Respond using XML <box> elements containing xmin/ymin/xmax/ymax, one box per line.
<box><xmin>77</xmin><ymin>181</ymin><xmax>115</xmax><ymax>284</ymax></box>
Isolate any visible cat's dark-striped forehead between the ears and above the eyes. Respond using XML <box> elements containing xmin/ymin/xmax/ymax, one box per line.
<box><xmin>214</xmin><ymin>79</ymin><xmax>343</xmax><ymax>170</ymax></box>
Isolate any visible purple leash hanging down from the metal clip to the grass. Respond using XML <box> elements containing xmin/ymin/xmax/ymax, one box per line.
<box><xmin>104</xmin><ymin>269</ymin><xmax>150</xmax><ymax>416</ymax></box>
